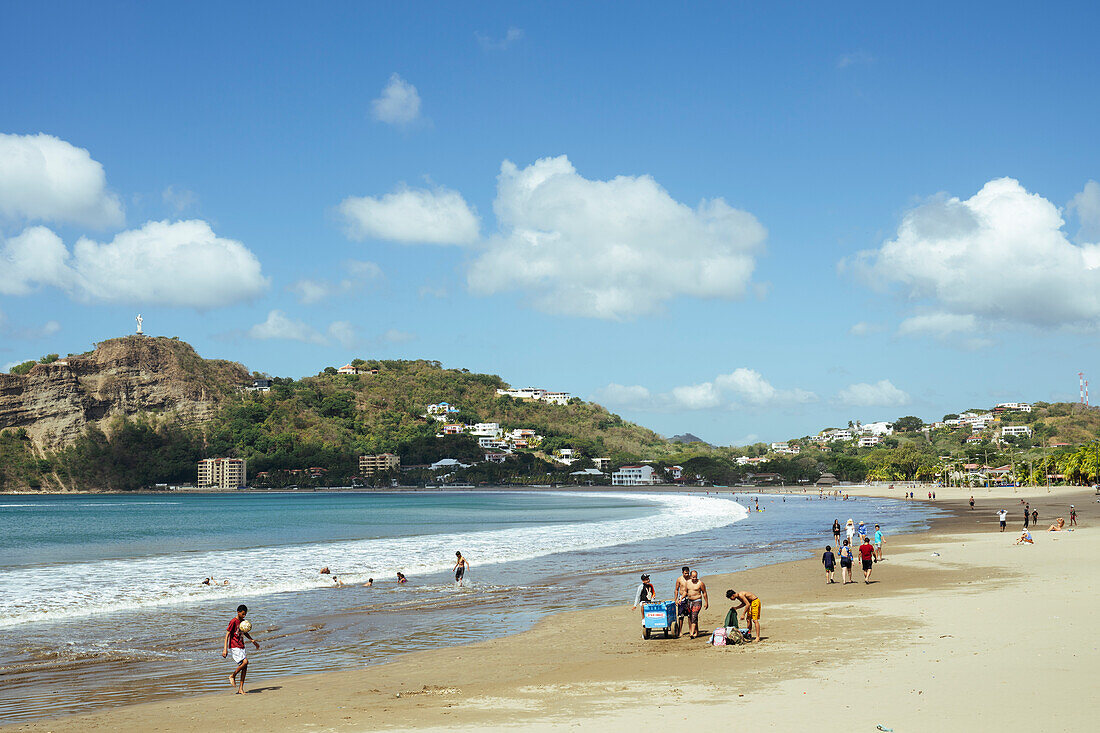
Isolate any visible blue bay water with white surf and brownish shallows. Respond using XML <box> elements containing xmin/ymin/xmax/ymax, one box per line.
<box><xmin>0</xmin><ymin>491</ymin><xmax>935</xmax><ymax>723</ymax></box>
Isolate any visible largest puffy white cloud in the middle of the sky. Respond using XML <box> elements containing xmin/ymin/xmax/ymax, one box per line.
<box><xmin>468</xmin><ymin>155</ymin><xmax>767</xmax><ymax>320</ymax></box>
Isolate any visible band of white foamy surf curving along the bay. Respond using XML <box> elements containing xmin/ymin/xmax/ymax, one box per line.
<box><xmin>0</xmin><ymin>493</ymin><xmax>748</xmax><ymax>627</ymax></box>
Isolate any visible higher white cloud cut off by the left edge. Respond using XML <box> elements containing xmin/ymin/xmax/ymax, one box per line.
<box><xmin>0</xmin><ymin>133</ymin><xmax>123</xmax><ymax>229</ymax></box>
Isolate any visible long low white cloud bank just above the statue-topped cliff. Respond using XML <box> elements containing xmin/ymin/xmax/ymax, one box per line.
<box><xmin>0</xmin><ymin>220</ymin><xmax>267</xmax><ymax>309</ymax></box>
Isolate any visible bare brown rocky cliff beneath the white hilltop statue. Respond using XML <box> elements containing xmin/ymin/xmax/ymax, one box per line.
<box><xmin>0</xmin><ymin>336</ymin><xmax>249</xmax><ymax>450</ymax></box>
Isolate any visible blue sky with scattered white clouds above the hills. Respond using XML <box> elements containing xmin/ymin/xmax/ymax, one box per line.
<box><xmin>0</xmin><ymin>3</ymin><xmax>1100</xmax><ymax>444</ymax></box>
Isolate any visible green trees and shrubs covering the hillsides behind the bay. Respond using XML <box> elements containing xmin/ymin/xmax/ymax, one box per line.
<box><xmin>0</xmin><ymin>343</ymin><xmax>1100</xmax><ymax>490</ymax></box>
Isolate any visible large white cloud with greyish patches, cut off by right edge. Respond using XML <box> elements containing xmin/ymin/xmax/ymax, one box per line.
<box><xmin>842</xmin><ymin>178</ymin><xmax>1100</xmax><ymax>328</ymax></box>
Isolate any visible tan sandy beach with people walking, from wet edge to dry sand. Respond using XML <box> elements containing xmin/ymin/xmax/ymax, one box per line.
<box><xmin>3</xmin><ymin>489</ymin><xmax>1100</xmax><ymax>732</ymax></box>
